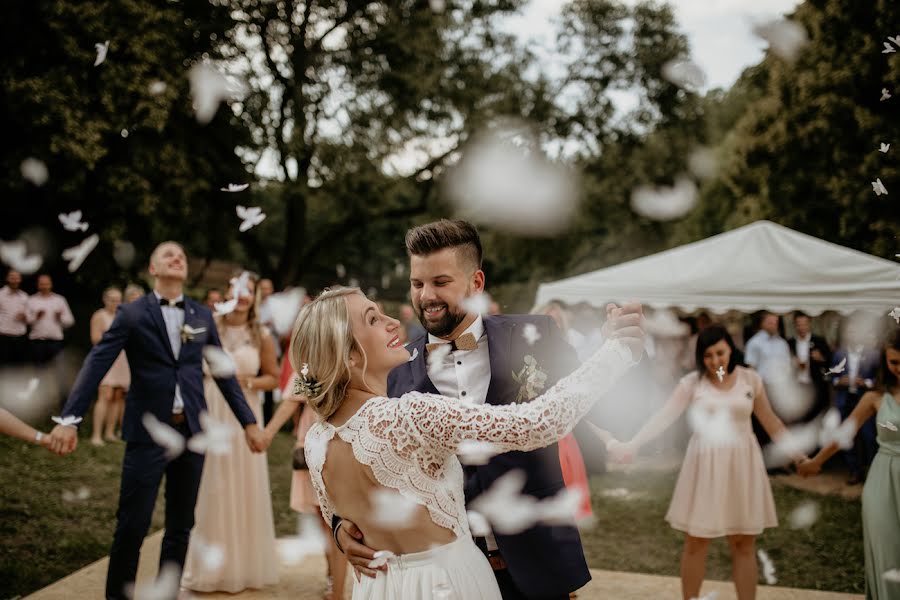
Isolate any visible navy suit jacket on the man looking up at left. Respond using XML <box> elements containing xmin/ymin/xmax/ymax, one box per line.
<box><xmin>62</xmin><ymin>293</ymin><xmax>256</xmax><ymax>442</ymax></box>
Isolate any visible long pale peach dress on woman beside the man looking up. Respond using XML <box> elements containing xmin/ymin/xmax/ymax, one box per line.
<box><xmin>181</xmin><ymin>323</ymin><xmax>278</xmax><ymax>594</ymax></box>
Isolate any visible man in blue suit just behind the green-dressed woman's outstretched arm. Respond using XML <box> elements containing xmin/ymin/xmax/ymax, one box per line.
<box><xmin>831</xmin><ymin>319</ymin><xmax>881</xmax><ymax>485</ymax></box>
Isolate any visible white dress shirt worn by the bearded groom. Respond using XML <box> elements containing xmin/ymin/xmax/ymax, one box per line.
<box><xmin>428</xmin><ymin>315</ymin><xmax>498</xmax><ymax>551</ymax></box>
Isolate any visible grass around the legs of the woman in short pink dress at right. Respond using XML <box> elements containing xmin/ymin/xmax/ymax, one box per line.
<box><xmin>581</xmin><ymin>472</ymin><xmax>865</xmax><ymax>593</ymax></box>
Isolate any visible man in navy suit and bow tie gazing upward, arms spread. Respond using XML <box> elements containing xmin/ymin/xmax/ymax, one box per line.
<box><xmin>51</xmin><ymin>242</ymin><xmax>262</xmax><ymax>600</ymax></box>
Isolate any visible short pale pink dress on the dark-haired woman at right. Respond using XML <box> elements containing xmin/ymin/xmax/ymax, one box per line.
<box><xmin>666</xmin><ymin>367</ymin><xmax>778</xmax><ymax>538</ymax></box>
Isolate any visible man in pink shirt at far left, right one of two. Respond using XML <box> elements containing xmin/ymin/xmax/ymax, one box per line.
<box><xmin>25</xmin><ymin>274</ymin><xmax>75</xmax><ymax>365</ymax></box>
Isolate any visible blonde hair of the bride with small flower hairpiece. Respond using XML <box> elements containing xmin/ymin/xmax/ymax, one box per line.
<box><xmin>290</xmin><ymin>287</ymin><xmax>365</xmax><ymax>421</ymax></box>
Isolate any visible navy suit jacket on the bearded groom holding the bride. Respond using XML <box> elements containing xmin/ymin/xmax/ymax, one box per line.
<box><xmin>388</xmin><ymin>315</ymin><xmax>591</xmax><ymax>598</ymax></box>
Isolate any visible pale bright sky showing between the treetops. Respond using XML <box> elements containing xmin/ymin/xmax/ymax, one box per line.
<box><xmin>508</xmin><ymin>0</ymin><xmax>800</xmax><ymax>89</ymax></box>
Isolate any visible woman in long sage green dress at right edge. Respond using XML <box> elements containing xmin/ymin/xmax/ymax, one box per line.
<box><xmin>797</xmin><ymin>329</ymin><xmax>900</xmax><ymax>600</ymax></box>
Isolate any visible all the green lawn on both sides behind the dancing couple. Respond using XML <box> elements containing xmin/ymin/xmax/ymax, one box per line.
<box><xmin>0</xmin><ymin>433</ymin><xmax>863</xmax><ymax>598</ymax></box>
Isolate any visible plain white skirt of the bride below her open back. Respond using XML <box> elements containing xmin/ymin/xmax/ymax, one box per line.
<box><xmin>353</xmin><ymin>537</ymin><xmax>501</xmax><ymax>600</ymax></box>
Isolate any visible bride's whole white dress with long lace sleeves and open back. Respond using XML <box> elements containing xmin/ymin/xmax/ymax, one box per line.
<box><xmin>306</xmin><ymin>341</ymin><xmax>634</xmax><ymax>600</ymax></box>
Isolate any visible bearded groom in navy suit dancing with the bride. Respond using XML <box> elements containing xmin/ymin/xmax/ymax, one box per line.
<box><xmin>333</xmin><ymin>220</ymin><xmax>591</xmax><ymax>600</ymax></box>
